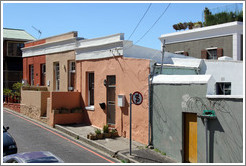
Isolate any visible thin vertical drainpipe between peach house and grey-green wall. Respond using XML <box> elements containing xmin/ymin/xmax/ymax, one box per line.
<box><xmin>148</xmin><ymin>63</ymin><xmax>156</xmax><ymax>147</ymax></box>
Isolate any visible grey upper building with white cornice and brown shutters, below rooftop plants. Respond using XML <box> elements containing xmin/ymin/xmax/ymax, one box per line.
<box><xmin>159</xmin><ymin>22</ymin><xmax>243</xmax><ymax>61</ymax></box>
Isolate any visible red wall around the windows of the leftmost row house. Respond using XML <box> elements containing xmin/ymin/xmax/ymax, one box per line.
<box><xmin>23</xmin><ymin>55</ymin><xmax>46</xmax><ymax>85</ymax></box>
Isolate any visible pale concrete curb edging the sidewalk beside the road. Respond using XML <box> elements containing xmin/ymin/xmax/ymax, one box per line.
<box><xmin>55</xmin><ymin>124</ymin><xmax>139</xmax><ymax>163</ymax></box>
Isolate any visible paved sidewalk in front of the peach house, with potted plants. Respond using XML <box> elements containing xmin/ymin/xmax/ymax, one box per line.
<box><xmin>55</xmin><ymin>124</ymin><xmax>175</xmax><ymax>163</ymax></box>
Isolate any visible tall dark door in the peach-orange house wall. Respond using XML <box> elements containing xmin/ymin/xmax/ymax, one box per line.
<box><xmin>107</xmin><ymin>76</ymin><xmax>116</xmax><ymax>125</ymax></box>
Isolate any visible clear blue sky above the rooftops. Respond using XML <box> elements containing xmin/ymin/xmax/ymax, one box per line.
<box><xmin>2</xmin><ymin>1</ymin><xmax>242</xmax><ymax>49</ymax></box>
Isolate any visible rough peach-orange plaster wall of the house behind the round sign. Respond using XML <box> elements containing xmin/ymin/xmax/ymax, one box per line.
<box><xmin>76</xmin><ymin>57</ymin><xmax>150</xmax><ymax>144</ymax></box>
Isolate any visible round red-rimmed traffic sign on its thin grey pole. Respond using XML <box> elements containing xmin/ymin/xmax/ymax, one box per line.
<box><xmin>129</xmin><ymin>91</ymin><xmax>143</xmax><ymax>155</ymax></box>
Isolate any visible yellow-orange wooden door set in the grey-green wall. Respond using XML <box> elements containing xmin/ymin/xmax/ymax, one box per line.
<box><xmin>184</xmin><ymin>113</ymin><xmax>197</xmax><ymax>163</ymax></box>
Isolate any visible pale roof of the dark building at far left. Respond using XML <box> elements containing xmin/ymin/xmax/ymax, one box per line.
<box><xmin>3</xmin><ymin>28</ymin><xmax>36</xmax><ymax>41</ymax></box>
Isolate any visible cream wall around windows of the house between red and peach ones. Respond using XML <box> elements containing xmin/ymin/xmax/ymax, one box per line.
<box><xmin>46</xmin><ymin>51</ymin><xmax>75</xmax><ymax>92</ymax></box>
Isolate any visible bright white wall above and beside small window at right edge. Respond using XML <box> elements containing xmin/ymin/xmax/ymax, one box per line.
<box><xmin>200</xmin><ymin>60</ymin><xmax>244</xmax><ymax>95</ymax></box>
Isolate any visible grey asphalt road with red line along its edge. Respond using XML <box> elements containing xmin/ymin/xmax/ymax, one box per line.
<box><xmin>3</xmin><ymin>110</ymin><xmax>119</xmax><ymax>163</ymax></box>
